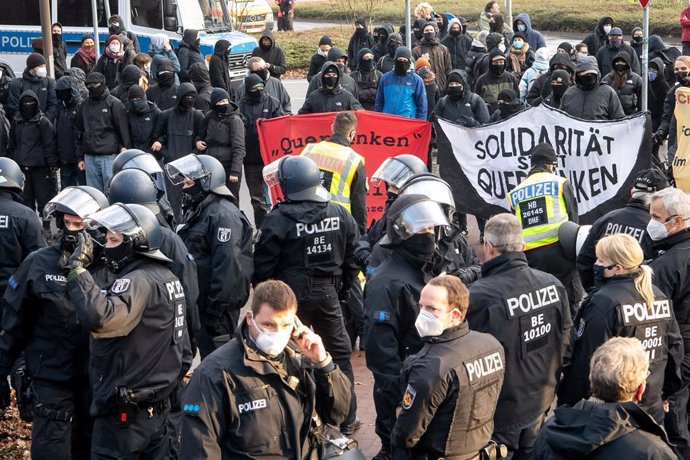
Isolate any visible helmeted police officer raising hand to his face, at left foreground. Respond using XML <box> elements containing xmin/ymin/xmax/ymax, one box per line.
<box><xmin>67</xmin><ymin>204</ymin><xmax>186</xmax><ymax>458</ymax></box>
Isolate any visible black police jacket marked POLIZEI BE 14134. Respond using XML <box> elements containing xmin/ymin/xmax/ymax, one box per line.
<box><xmin>254</xmin><ymin>201</ymin><xmax>359</xmax><ymax>299</ymax></box>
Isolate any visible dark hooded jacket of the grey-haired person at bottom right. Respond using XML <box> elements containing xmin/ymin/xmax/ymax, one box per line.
<box><xmin>533</xmin><ymin>400</ymin><xmax>677</xmax><ymax>460</ymax></box>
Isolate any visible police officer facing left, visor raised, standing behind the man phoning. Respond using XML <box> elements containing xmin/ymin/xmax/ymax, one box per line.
<box><xmin>165</xmin><ymin>154</ymin><xmax>254</xmax><ymax>358</ymax></box>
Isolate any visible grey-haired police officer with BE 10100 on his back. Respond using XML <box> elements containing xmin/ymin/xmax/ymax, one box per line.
<box><xmin>467</xmin><ymin>214</ymin><xmax>573</xmax><ymax>458</ymax></box>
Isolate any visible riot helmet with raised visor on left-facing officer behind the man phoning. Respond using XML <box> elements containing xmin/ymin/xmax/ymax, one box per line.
<box><xmin>165</xmin><ymin>153</ymin><xmax>235</xmax><ymax>198</ymax></box>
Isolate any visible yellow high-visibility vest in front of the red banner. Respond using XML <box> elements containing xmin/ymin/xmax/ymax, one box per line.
<box><xmin>301</xmin><ymin>141</ymin><xmax>364</xmax><ymax>212</ymax></box>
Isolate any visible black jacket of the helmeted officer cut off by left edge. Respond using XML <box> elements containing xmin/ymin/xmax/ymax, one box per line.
<box><xmin>0</xmin><ymin>189</ymin><xmax>46</xmax><ymax>293</ymax></box>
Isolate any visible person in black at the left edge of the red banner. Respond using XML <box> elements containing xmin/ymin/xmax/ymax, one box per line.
<box><xmin>238</xmin><ymin>74</ymin><xmax>285</xmax><ymax>228</ymax></box>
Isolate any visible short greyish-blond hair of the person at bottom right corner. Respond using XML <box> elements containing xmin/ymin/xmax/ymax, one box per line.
<box><xmin>589</xmin><ymin>337</ymin><xmax>649</xmax><ymax>402</ymax></box>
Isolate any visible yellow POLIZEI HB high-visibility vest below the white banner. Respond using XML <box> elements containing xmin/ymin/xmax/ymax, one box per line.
<box><xmin>509</xmin><ymin>172</ymin><xmax>568</xmax><ymax>251</ymax></box>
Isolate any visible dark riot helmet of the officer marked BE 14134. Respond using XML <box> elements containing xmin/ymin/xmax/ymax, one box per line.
<box><xmin>263</xmin><ymin>155</ymin><xmax>330</xmax><ymax>202</ymax></box>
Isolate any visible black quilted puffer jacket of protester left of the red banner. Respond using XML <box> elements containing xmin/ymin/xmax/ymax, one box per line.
<box><xmin>194</xmin><ymin>101</ymin><xmax>245</xmax><ymax>177</ymax></box>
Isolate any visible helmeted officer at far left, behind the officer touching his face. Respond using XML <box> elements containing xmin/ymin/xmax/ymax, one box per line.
<box><xmin>0</xmin><ymin>186</ymin><xmax>108</xmax><ymax>460</ymax></box>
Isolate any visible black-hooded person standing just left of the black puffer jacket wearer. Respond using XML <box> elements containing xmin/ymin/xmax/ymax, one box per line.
<box><xmin>151</xmin><ymin>83</ymin><xmax>204</xmax><ymax>164</ymax></box>
